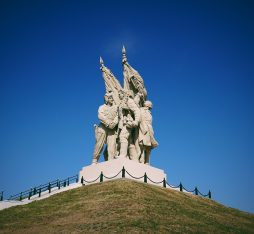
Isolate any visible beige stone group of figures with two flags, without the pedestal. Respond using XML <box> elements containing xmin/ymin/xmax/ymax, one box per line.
<box><xmin>92</xmin><ymin>47</ymin><xmax>158</xmax><ymax>164</ymax></box>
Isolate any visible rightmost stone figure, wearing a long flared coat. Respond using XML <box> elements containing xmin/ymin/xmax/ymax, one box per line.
<box><xmin>139</xmin><ymin>101</ymin><xmax>158</xmax><ymax>164</ymax></box>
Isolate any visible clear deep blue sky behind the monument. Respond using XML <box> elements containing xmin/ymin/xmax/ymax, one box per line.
<box><xmin>0</xmin><ymin>0</ymin><xmax>254</xmax><ymax>213</ymax></box>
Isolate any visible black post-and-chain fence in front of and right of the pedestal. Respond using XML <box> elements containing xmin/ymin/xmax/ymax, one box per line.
<box><xmin>81</xmin><ymin>167</ymin><xmax>212</xmax><ymax>199</ymax></box>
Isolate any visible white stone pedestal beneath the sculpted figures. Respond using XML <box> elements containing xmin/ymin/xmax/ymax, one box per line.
<box><xmin>79</xmin><ymin>158</ymin><xmax>167</xmax><ymax>186</ymax></box>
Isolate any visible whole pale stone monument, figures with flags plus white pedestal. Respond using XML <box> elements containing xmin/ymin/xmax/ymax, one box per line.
<box><xmin>80</xmin><ymin>46</ymin><xmax>166</xmax><ymax>185</ymax></box>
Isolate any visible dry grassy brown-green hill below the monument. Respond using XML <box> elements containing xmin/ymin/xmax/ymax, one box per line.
<box><xmin>0</xmin><ymin>180</ymin><xmax>254</xmax><ymax>234</ymax></box>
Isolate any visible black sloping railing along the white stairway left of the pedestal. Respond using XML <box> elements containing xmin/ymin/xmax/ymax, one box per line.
<box><xmin>7</xmin><ymin>175</ymin><xmax>78</xmax><ymax>201</ymax></box>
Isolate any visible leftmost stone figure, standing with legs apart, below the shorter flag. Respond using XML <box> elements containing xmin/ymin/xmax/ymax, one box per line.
<box><xmin>92</xmin><ymin>94</ymin><xmax>118</xmax><ymax>163</ymax></box>
